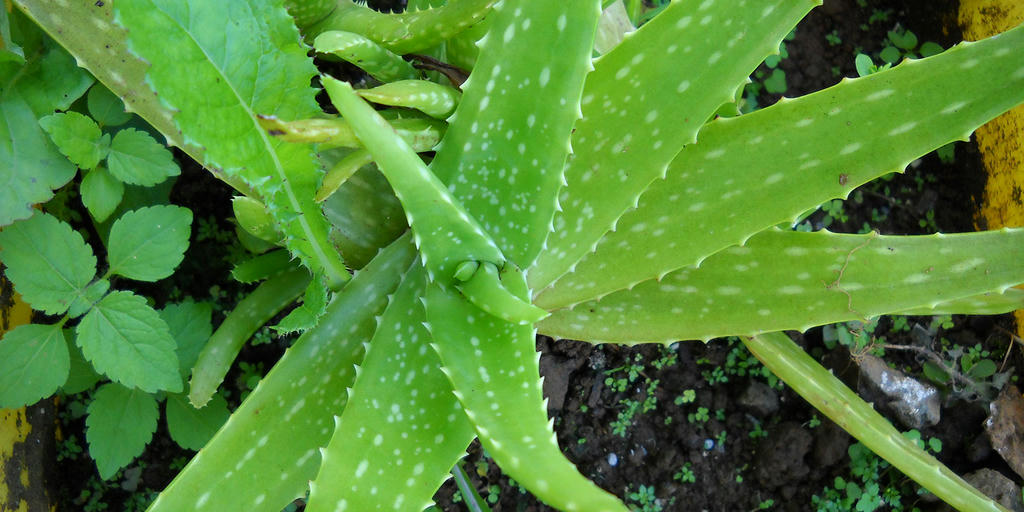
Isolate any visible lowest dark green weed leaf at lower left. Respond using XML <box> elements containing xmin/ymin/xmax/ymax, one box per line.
<box><xmin>85</xmin><ymin>382</ymin><xmax>160</xmax><ymax>480</ymax></box>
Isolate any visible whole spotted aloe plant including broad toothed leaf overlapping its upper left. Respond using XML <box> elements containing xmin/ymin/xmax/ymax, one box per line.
<box><xmin>6</xmin><ymin>0</ymin><xmax>1024</xmax><ymax>512</ymax></box>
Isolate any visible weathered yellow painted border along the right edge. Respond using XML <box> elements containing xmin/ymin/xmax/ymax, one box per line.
<box><xmin>957</xmin><ymin>0</ymin><xmax>1024</xmax><ymax>337</ymax></box>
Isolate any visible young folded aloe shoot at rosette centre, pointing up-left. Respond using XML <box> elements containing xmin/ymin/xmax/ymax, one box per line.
<box><xmin>324</xmin><ymin>77</ymin><xmax>548</xmax><ymax>325</ymax></box>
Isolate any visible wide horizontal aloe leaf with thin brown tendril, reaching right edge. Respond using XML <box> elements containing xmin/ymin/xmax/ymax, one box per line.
<box><xmin>540</xmin><ymin>229</ymin><xmax>1024</xmax><ymax>343</ymax></box>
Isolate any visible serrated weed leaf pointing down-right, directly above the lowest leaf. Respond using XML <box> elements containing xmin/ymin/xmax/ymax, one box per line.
<box><xmin>76</xmin><ymin>291</ymin><xmax>181</xmax><ymax>392</ymax></box>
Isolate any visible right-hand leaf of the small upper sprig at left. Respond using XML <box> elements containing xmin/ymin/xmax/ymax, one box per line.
<box><xmin>106</xmin><ymin>128</ymin><xmax>181</xmax><ymax>186</ymax></box>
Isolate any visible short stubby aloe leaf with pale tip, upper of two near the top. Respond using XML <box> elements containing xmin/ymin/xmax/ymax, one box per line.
<box><xmin>313</xmin><ymin>31</ymin><xmax>420</xmax><ymax>82</ymax></box>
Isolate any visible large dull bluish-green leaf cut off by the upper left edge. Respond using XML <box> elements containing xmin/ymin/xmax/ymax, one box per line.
<box><xmin>0</xmin><ymin>90</ymin><xmax>77</xmax><ymax>226</ymax></box>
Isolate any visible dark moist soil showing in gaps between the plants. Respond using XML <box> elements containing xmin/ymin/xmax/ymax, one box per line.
<box><xmin>44</xmin><ymin>0</ymin><xmax>1024</xmax><ymax>512</ymax></box>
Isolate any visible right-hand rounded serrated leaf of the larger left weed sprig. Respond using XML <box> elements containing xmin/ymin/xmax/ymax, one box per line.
<box><xmin>106</xmin><ymin>205</ymin><xmax>193</xmax><ymax>281</ymax></box>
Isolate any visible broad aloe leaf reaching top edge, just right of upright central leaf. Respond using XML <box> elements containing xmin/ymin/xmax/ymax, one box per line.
<box><xmin>527</xmin><ymin>0</ymin><xmax>821</xmax><ymax>291</ymax></box>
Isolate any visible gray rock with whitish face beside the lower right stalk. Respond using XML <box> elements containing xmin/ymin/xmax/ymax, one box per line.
<box><xmin>857</xmin><ymin>354</ymin><xmax>942</xmax><ymax>429</ymax></box>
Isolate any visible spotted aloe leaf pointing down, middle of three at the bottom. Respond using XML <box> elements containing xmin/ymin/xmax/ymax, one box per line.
<box><xmin>307</xmin><ymin>264</ymin><xmax>475</xmax><ymax>512</ymax></box>
